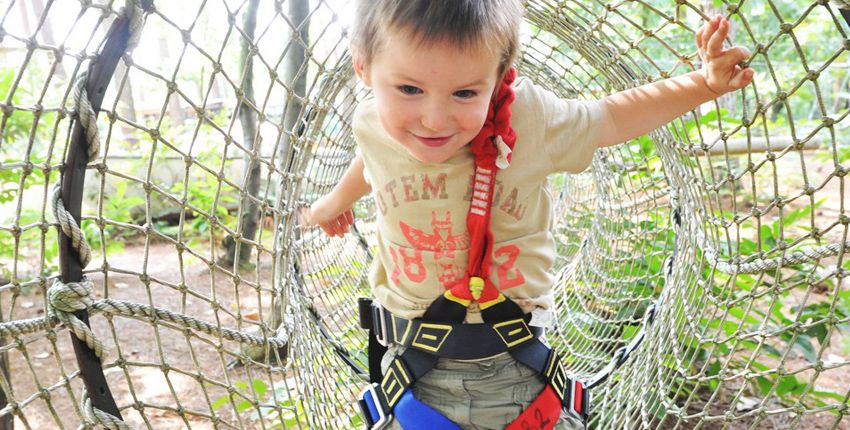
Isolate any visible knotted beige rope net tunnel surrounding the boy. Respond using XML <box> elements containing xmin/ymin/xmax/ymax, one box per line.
<box><xmin>0</xmin><ymin>0</ymin><xmax>850</xmax><ymax>429</ymax></box>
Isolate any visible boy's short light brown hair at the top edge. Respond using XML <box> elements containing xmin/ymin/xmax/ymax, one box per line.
<box><xmin>351</xmin><ymin>0</ymin><xmax>522</xmax><ymax>76</ymax></box>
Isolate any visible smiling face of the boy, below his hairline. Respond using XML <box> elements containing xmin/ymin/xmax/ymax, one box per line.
<box><xmin>355</xmin><ymin>31</ymin><xmax>500</xmax><ymax>163</ymax></box>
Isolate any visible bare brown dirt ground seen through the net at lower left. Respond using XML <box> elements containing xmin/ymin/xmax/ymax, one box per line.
<box><xmin>4</xmin><ymin>243</ymin><xmax>284</xmax><ymax>429</ymax></box>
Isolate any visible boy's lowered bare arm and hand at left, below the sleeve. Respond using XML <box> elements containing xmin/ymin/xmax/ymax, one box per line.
<box><xmin>302</xmin><ymin>155</ymin><xmax>372</xmax><ymax>236</ymax></box>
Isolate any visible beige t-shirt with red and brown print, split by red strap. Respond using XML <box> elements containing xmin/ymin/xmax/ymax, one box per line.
<box><xmin>353</xmin><ymin>78</ymin><xmax>603</xmax><ymax>323</ymax></box>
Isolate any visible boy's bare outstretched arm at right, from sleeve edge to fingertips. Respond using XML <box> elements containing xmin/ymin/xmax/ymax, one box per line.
<box><xmin>598</xmin><ymin>16</ymin><xmax>754</xmax><ymax>147</ymax></box>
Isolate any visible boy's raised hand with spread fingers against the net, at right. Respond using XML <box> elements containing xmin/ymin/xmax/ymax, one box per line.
<box><xmin>696</xmin><ymin>15</ymin><xmax>755</xmax><ymax>96</ymax></box>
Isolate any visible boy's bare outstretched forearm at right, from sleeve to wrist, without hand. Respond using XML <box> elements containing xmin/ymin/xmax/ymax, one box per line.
<box><xmin>599</xmin><ymin>71</ymin><xmax>721</xmax><ymax>147</ymax></box>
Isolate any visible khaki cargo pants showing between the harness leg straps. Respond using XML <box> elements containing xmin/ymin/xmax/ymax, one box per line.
<box><xmin>381</xmin><ymin>345</ymin><xmax>584</xmax><ymax>430</ymax></box>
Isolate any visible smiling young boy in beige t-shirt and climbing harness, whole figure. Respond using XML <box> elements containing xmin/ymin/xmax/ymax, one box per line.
<box><xmin>304</xmin><ymin>0</ymin><xmax>753</xmax><ymax>430</ymax></box>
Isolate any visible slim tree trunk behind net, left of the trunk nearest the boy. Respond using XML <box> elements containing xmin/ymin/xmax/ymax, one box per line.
<box><xmin>224</xmin><ymin>0</ymin><xmax>261</xmax><ymax>267</ymax></box>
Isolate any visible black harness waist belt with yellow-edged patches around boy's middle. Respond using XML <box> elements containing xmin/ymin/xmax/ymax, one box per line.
<box><xmin>360</xmin><ymin>299</ymin><xmax>543</xmax><ymax>360</ymax></box>
